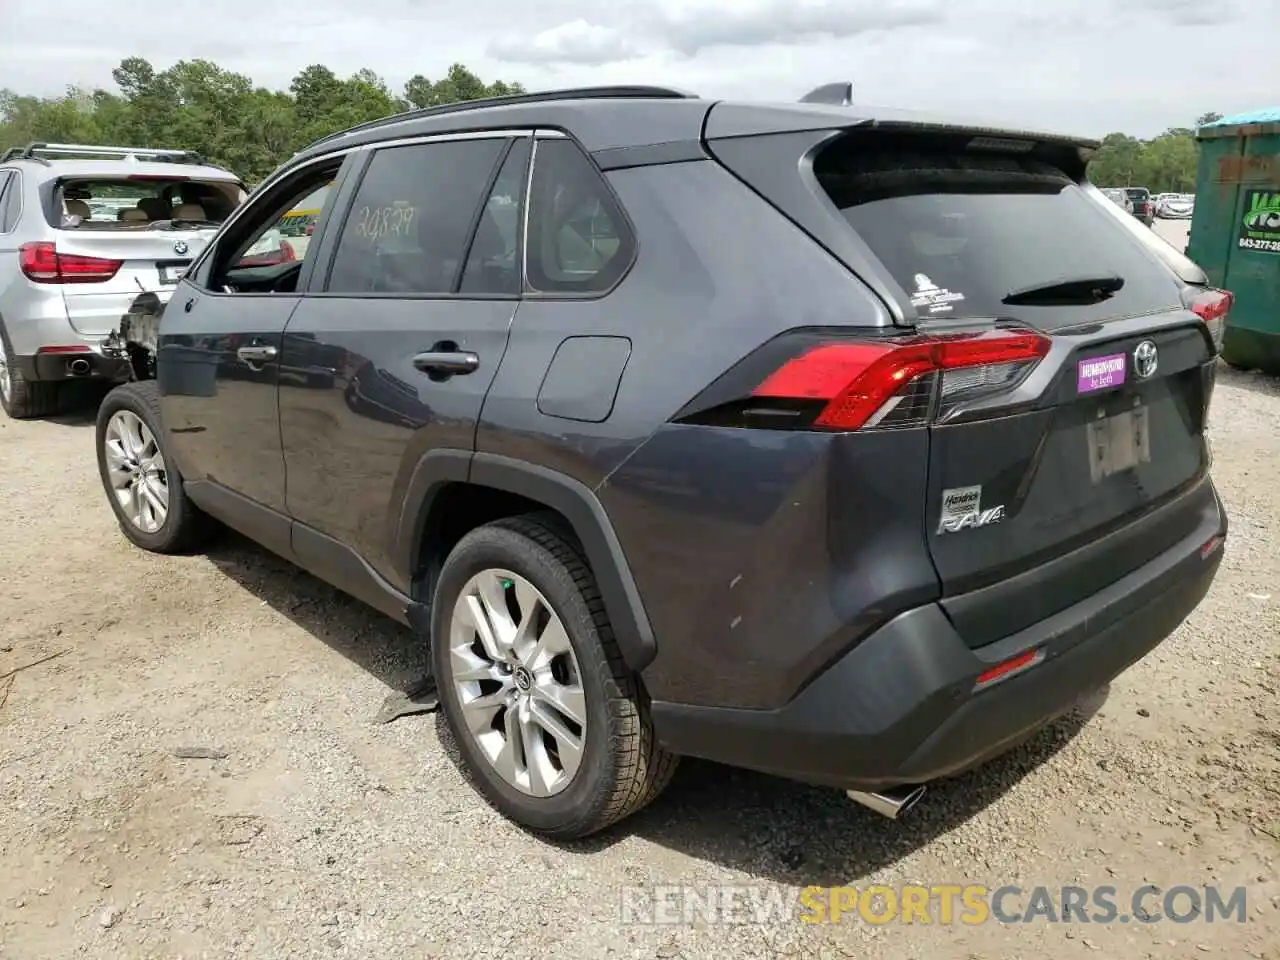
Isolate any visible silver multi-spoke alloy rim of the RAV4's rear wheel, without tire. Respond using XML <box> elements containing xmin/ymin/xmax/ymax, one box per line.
<box><xmin>448</xmin><ymin>570</ymin><xmax>588</xmax><ymax>797</ymax></box>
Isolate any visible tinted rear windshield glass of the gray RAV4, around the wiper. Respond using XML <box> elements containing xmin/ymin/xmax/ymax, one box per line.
<box><xmin>814</xmin><ymin>137</ymin><xmax>1180</xmax><ymax>329</ymax></box>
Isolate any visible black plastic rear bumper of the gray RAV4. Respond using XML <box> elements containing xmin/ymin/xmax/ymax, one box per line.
<box><xmin>653</xmin><ymin>480</ymin><xmax>1228</xmax><ymax>790</ymax></box>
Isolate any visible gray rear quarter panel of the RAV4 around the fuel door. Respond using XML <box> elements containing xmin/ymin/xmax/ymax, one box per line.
<box><xmin>477</xmin><ymin>160</ymin><xmax>937</xmax><ymax>707</ymax></box>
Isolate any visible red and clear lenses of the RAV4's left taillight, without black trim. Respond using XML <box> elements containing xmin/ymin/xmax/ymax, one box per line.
<box><xmin>751</xmin><ymin>329</ymin><xmax>1050</xmax><ymax>430</ymax></box>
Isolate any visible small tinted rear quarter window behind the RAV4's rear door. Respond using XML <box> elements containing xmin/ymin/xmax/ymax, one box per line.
<box><xmin>526</xmin><ymin>140</ymin><xmax>634</xmax><ymax>293</ymax></box>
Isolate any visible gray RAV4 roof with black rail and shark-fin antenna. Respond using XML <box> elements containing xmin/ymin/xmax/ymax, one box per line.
<box><xmin>288</xmin><ymin>84</ymin><xmax>1098</xmax><ymax>165</ymax></box>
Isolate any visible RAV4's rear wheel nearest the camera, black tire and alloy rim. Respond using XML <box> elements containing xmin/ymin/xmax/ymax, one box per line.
<box><xmin>431</xmin><ymin>517</ymin><xmax>677</xmax><ymax>840</ymax></box>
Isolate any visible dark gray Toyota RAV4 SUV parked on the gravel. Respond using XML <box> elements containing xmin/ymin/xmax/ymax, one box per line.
<box><xmin>90</xmin><ymin>84</ymin><xmax>1231</xmax><ymax>837</ymax></box>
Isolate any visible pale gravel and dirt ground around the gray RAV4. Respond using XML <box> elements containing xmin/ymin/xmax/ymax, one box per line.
<box><xmin>0</xmin><ymin>369</ymin><xmax>1280</xmax><ymax>960</ymax></box>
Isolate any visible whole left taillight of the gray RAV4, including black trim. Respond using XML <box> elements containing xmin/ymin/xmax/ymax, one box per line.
<box><xmin>677</xmin><ymin>329</ymin><xmax>1050</xmax><ymax>430</ymax></box>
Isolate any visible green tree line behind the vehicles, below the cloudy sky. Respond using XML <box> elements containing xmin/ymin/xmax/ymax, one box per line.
<box><xmin>0</xmin><ymin>56</ymin><xmax>1217</xmax><ymax>193</ymax></box>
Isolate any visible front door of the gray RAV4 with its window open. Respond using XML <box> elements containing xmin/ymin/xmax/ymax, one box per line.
<box><xmin>156</xmin><ymin>152</ymin><xmax>353</xmax><ymax>537</ymax></box>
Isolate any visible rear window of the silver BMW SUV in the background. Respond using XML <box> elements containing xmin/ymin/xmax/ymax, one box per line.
<box><xmin>46</xmin><ymin>177</ymin><xmax>246</xmax><ymax>230</ymax></box>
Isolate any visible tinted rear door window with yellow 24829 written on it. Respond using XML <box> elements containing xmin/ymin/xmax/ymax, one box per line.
<box><xmin>328</xmin><ymin>140</ymin><xmax>506</xmax><ymax>294</ymax></box>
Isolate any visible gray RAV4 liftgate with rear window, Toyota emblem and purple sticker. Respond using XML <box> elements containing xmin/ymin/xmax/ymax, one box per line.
<box><xmin>817</xmin><ymin>136</ymin><xmax>1212</xmax><ymax>643</ymax></box>
